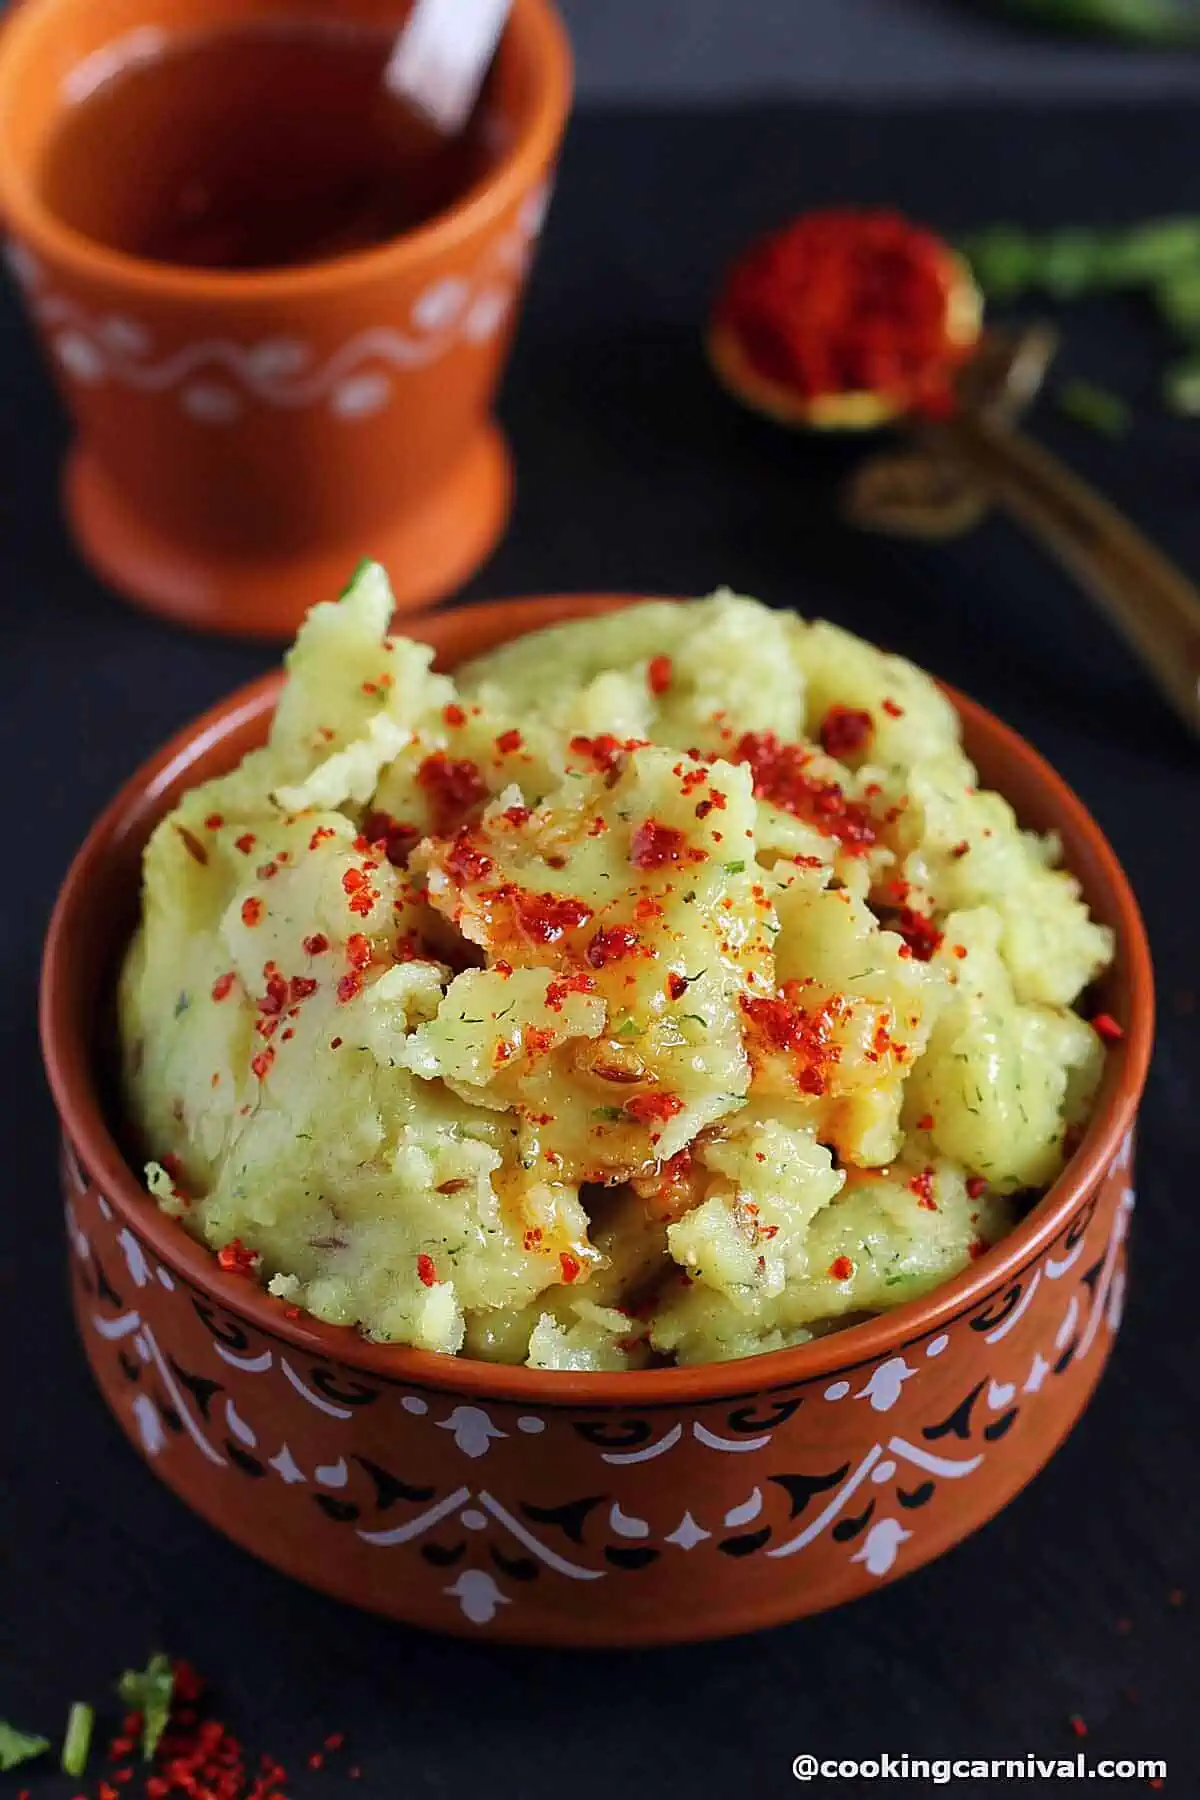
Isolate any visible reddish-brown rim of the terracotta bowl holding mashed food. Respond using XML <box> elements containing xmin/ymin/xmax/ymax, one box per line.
<box><xmin>40</xmin><ymin>594</ymin><xmax>1153</xmax><ymax>1411</ymax></box>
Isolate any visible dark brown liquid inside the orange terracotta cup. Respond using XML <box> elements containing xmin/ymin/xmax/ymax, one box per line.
<box><xmin>41</xmin><ymin>20</ymin><xmax>495</xmax><ymax>270</ymax></box>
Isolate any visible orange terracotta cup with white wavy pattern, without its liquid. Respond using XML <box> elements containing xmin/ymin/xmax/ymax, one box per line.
<box><xmin>0</xmin><ymin>0</ymin><xmax>570</xmax><ymax>635</ymax></box>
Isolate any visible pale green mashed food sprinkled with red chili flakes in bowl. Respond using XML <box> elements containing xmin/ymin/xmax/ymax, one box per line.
<box><xmin>121</xmin><ymin>565</ymin><xmax>1112</xmax><ymax>1370</ymax></box>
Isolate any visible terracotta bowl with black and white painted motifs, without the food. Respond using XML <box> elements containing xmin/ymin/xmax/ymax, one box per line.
<box><xmin>41</xmin><ymin>596</ymin><xmax>1153</xmax><ymax>1645</ymax></box>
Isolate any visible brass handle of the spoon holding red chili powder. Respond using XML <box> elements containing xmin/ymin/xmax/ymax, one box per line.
<box><xmin>937</xmin><ymin>409</ymin><xmax>1200</xmax><ymax>736</ymax></box>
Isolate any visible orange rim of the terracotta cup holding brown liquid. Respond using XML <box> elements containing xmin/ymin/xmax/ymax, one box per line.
<box><xmin>0</xmin><ymin>0</ymin><xmax>574</xmax><ymax>301</ymax></box>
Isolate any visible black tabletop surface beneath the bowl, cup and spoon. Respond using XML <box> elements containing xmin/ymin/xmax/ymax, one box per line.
<box><xmin>0</xmin><ymin>106</ymin><xmax>1200</xmax><ymax>1800</ymax></box>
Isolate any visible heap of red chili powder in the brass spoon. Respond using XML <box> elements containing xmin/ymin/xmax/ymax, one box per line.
<box><xmin>714</xmin><ymin>207</ymin><xmax>964</xmax><ymax>414</ymax></box>
